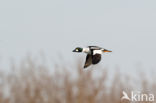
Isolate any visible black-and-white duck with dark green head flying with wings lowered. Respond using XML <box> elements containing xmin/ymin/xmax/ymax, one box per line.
<box><xmin>73</xmin><ymin>46</ymin><xmax>112</xmax><ymax>68</ymax></box>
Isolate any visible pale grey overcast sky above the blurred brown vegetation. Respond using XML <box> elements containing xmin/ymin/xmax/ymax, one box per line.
<box><xmin>0</xmin><ymin>0</ymin><xmax>156</xmax><ymax>71</ymax></box>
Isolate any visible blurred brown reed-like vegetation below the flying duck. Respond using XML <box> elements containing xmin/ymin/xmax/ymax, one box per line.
<box><xmin>0</xmin><ymin>58</ymin><xmax>156</xmax><ymax>103</ymax></box>
